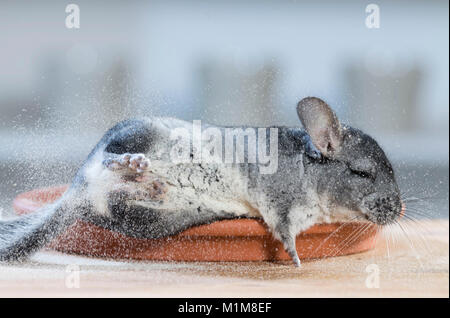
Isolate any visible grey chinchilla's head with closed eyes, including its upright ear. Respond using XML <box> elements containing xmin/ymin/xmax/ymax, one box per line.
<box><xmin>297</xmin><ymin>97</ymin><xmax>402</xmax><ymax>225</ymax></box>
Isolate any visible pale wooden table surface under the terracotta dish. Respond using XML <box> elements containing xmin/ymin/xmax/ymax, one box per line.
<box><xmin>0</xmin><ymin>220</ymin><xmax>449</xmax><ymax>297</ymax></box>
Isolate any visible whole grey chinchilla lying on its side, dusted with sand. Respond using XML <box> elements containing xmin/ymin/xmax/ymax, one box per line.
<box><xmin>0</xmin><ymin>98</ymin><xmax>401</xmax><ymax>265</ymax></box>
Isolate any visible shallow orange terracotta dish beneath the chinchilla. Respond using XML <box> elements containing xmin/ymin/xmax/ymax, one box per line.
<box><xmin>14</xmin><ymin>186</ymin><xmax>377</xmax><ymax>261</ymax></box>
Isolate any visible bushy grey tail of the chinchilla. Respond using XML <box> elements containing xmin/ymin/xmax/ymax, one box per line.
<box><xmin>0</xmin><ymin>189</ymin><xmax>81</xmax><ymax>262</ymax></box>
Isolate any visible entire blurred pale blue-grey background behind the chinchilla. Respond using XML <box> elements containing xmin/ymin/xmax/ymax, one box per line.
<box><xmin>0</xmin><ymin>0</ymin><xmax>449</xmax><ymax>217</ymax></box>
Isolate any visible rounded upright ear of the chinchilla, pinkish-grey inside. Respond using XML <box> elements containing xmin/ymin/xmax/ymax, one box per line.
<box><xmin>297</xmin><ymin>97</ymin><xmax>342</xmax><ymax>157</ymax></box>
